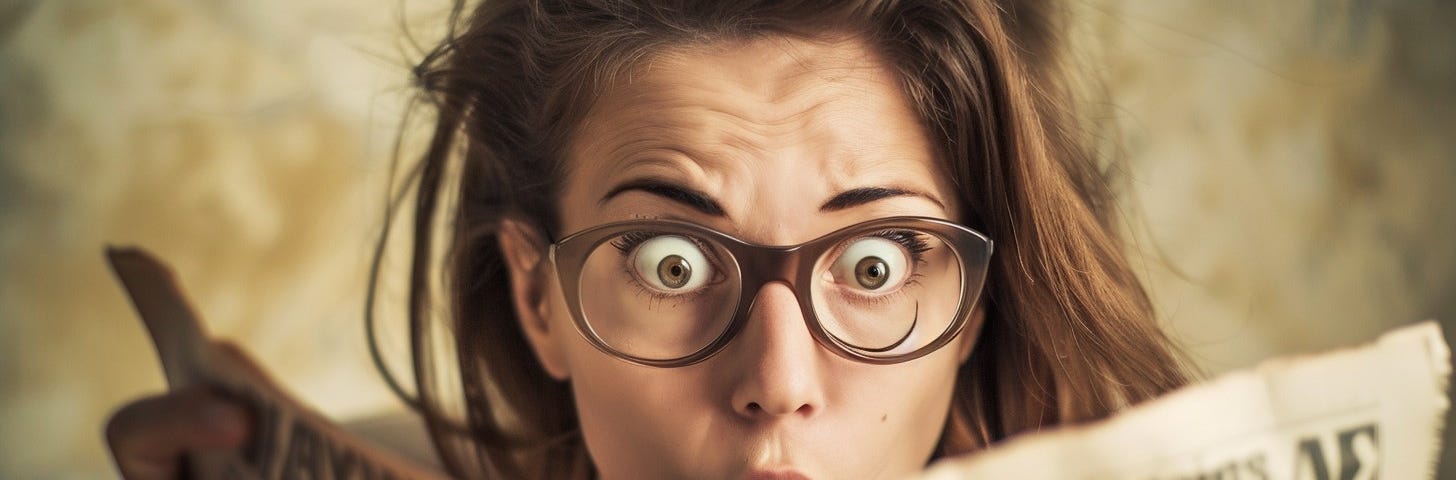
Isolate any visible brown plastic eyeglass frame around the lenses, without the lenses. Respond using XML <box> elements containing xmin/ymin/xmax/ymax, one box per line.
<box><xmin>547</xmin><ymin>215</ymin><xmax>994</xmax><ymax>368</ymax></box>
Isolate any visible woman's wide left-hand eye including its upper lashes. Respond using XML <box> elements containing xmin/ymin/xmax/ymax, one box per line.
<box><xmin>613</xmin><ymin>231</ymin><xmax>716</xmax><ymax>295</ymax></box>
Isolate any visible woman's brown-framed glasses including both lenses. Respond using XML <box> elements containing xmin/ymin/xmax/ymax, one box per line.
<box><xmin>550</xmin><ymin>217</ymin><xmax>993</xmax><ymax>368</ymax></box>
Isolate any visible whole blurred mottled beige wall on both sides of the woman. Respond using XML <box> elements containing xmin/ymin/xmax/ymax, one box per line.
<box><xmin>0</xmin><ymin>0</ymin><xmax>1456</xmax><ymax>479</ymax></box>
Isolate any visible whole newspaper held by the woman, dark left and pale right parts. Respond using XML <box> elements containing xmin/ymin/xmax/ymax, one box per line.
<box><xmin>108</xmin><ymin>249</ymin><xmax>1450</xmax><ymax>480</ymax></box>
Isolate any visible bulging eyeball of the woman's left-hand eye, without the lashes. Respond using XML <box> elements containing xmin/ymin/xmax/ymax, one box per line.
<box><xmin>632</xmin><ymin>236</ymin><xmax>713</xmax><ymax>292</ymax></box>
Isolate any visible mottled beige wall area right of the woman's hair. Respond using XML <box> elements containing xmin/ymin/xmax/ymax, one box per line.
<box><xmin>1073</xmin><ymin>0</ymin><xmax>1456</xmax><ymax>371</ymax></box>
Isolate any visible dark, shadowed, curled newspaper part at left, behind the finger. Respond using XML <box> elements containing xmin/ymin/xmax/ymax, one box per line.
<box><xmin>106</xmin><ymin>249</ymin><xmax>444</xmax><ymax>480</ymax></box>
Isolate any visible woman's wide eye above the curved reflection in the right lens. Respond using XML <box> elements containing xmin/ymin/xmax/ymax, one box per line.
<box><xmin>828</xmin><ymin>230</ymin><xmax>929</xmax><ymax>295</ymax></box>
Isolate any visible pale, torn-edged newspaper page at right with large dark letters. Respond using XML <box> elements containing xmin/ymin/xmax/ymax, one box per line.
<box><xmin>920</xmin><ymin>321</ymin><xmax>1450</xmax><ymax>480</ymax></box>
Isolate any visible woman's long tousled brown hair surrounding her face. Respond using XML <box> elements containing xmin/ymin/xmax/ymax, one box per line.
<box><xmin>380</xmin><ymin>0</ymin><xmax>1185</xmax><ymax>479</ymax></box>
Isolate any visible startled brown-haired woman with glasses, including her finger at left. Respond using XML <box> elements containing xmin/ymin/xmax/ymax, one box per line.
<box><xmin>111</xmin><ymin>0</ymin><xmax>1185</xmax><ymax>479</ymax></box>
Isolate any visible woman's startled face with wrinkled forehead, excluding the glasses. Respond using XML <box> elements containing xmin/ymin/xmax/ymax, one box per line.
<box><xmin>502</xmin><ymin>38</ymin><xmax>978</xmax><ymax>480</ymax></box>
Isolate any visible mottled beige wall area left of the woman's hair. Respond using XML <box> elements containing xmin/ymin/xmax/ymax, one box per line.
<box><xmin>0</xmin><ymin>0</ymin><xmax>428</xmax><ymax>479</ymax></box>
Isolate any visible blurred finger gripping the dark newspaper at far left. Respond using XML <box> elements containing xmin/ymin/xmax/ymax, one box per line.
<box><xmin>106</xmin><ymin>388</ymin><xmax>252</xmax><ymax>480</ymax></box>
